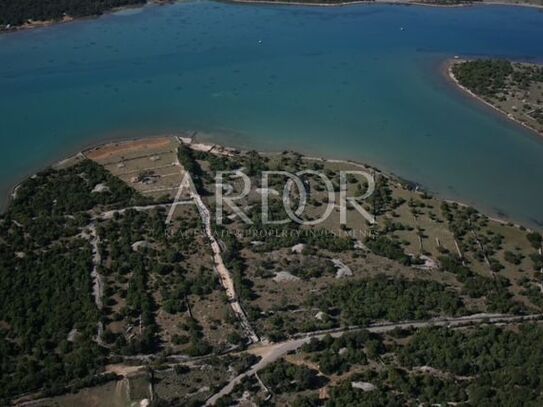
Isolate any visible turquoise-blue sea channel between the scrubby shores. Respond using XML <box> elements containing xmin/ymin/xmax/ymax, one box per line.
<box><xmin>0</xmin><ymin>1</ymin><xmax>543</xmax><ymax>225</ymax></box>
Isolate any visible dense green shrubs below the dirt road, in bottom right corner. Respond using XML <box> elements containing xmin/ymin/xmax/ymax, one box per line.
<box><xmin>304</xmin><ymin>324</ymin><xmax>543</xmax><ymax>407</ymax></box>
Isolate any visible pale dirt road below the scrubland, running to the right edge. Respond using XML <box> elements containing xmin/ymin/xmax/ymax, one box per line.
<box><xmin>206</xmin><ymin>314</ymin><xmax>543</xmax><ymax>406</ymax></box>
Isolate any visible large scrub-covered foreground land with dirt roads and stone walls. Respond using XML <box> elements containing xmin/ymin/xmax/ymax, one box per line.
<box><xmin>0</xmin><ymin>136</ymin><xmax>543</xmax><ymax>407</ymax></box>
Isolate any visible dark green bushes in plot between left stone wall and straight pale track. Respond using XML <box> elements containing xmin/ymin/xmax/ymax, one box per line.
<box><xmin>98</xmin><ymin>210</ymin><xmax>218</xmax><ymax>356</ymax></box>
